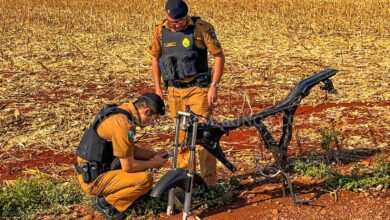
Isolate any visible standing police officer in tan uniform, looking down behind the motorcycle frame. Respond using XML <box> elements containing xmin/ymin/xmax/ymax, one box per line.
<box><xmin>150</xmin><ymin>0</ymin><xmax>225</xmax><ymax>184</ymax></box>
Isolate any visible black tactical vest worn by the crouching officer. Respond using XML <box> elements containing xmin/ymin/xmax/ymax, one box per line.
<box><xmin>77</xmin><ymin>105</ymin><xmax>134</xmax><ymax>163</ymax></box>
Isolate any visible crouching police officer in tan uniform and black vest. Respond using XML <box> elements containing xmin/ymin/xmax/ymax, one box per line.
<box><xmin>76</xmin><ymin>93</ymin><xmax>167</xmax><ymax>219</ymax></box>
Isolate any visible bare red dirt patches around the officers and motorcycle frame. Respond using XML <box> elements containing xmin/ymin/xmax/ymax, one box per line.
<box><xmin>0</xmin><ymin>102</ymin><xmax>390</xmax><ymax>220</ymax></box>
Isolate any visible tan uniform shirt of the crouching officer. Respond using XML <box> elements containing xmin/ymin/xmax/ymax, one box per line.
<box><xmin>77</xmin><ymin>103</ymin><xmax>139</xmax><ymax>164</ymax></box>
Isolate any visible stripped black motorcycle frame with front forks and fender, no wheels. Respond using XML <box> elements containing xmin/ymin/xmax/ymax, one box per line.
<box><xmin>151</xmin><ymin>68</ymin><xmax>338</xmax><ymax>219</ymax></box>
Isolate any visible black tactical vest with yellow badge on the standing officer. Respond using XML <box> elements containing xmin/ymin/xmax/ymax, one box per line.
<box><xmin>159</xmin><ymin>17</ymin><xmax>208</xmax><ymax>81</ymax></box>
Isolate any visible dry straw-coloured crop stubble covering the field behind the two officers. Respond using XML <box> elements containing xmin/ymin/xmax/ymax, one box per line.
<box><xmin>0</xmin><ymin>0</ymin><xmax>390</xmax><ymax>151</ymax></box>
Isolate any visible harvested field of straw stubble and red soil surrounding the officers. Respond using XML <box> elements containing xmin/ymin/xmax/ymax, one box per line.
<box><xmin>0</xmin><ymin>0</ymin><xmax>390</xmax><ymax>219</ymax></box>
